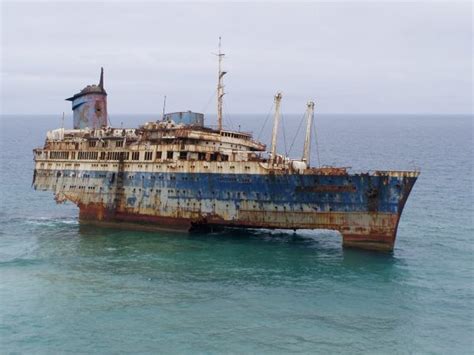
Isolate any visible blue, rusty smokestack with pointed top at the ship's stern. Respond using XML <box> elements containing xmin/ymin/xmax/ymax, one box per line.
<box><xmin>66</xmin><ymin>68</ymin><xmax>107</xmax><ymax>129</ymax></box>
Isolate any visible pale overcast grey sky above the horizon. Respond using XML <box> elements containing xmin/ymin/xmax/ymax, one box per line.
<box><xmin>1</xmin><ymin>1</ymin><xmax>472</xmax><ymax>114</ymax></box>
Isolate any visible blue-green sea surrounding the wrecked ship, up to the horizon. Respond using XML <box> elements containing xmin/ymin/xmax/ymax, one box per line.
<box><xmin>0</xmin><ymin>114</ymin><xmax>474</xmax><ymax>354</ymax></box>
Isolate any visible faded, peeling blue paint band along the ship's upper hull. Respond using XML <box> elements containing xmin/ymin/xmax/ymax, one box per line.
<box><xmin>48</xmin><ymin>170</ymin><xmax>416</xmax><ymax>214</ymax></box>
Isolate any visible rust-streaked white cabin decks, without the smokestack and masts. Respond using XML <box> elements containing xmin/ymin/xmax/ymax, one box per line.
<box><xmin>35</xmin><ymin>117</ymin><xmax>266</xmax><ymax>166</ymax></box>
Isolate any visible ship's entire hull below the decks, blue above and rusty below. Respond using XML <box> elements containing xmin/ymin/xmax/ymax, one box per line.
<box><xmin>35</xmin><ymin>171</ymin><xmax>417</xmax><ymax>251</ymax></box>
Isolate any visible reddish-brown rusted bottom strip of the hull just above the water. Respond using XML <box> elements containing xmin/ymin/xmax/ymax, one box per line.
<box><xmin>79</xmin><ymin>204</ymin><xmax>406</xmax><ymax>251</ymax></box>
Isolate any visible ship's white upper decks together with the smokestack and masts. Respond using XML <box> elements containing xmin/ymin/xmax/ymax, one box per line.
<box><xmin>34</xmin><ymin>59</ymin><xmax>314</xmax><ymax>171</ymax></box>
